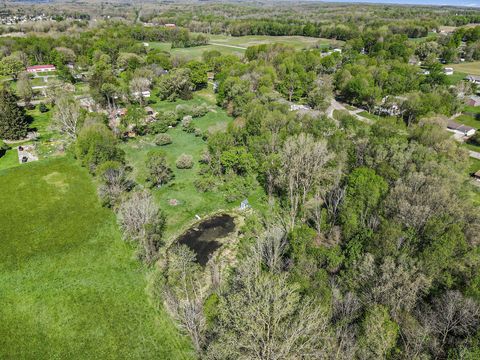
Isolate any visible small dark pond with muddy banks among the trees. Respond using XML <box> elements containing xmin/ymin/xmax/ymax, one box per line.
<box><xmin>178</xmin><ymin>214</ymin><xmax>235</xmax><ymax>266</ymax></box>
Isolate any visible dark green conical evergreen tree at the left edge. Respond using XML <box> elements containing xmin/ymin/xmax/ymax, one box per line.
<box><xmin>0</xmin><ymin>89</ymin><xmax>28</xmax><ymax>140</ymax></box>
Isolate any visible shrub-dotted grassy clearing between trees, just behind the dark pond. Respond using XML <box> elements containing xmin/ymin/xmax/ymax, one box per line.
<box><xmin>124</xmin><ymin>96</ymin><xmax>238</xmax><ymax>237</ymax></box>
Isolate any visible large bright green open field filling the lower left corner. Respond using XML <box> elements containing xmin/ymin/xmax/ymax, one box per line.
<box><xmin>0</xmin><ymin>158</ymin><xmax>191</xmax><ymax>359</ymax></box>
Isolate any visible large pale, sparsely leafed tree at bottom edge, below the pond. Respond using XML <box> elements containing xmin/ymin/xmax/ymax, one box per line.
<box><xmin>206</xmin><ymin>232</ymin><xmax>332</xmax><ymax>360</ymax></box>
